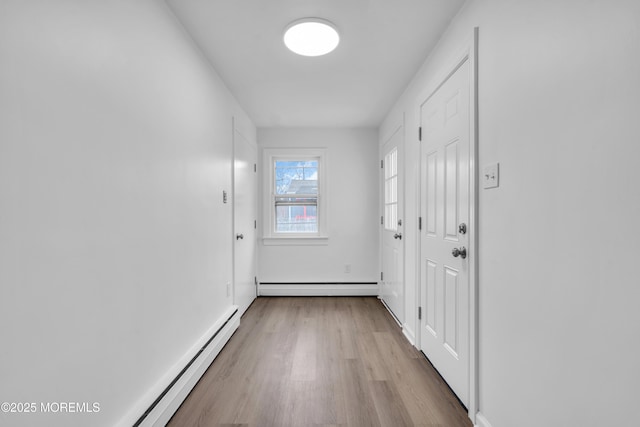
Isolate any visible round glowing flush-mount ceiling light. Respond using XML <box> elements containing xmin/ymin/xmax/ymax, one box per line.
<box><xmin>284</xmin><ymin>18</ymin><xmax>340</xmax><ymax>56</ymax></box>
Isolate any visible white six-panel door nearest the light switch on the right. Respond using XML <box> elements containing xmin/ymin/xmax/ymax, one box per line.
<box><xmin>420</xmin><ymin>59</ymin><xmax>471</xmax><ymax>407</ymax></box>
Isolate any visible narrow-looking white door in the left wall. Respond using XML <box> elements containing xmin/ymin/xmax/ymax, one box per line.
<box><xmin>233</xmin><ymin>125</ymin><xmax>257</xmax><ymax>314</ymax></box>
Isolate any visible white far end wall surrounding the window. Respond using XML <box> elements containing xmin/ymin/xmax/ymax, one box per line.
<box><xmin>258</xmin><ymin>128</ymin><xmax>380</xmax><ymax>282</ymax></box>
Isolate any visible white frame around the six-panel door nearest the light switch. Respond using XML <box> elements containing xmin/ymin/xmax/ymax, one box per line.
<box><xmin>415</xmin><ymin>27</ymin><xmax>480</xmax><ymax>424</ymax></box>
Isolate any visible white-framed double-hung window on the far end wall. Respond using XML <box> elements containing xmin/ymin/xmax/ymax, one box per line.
<box><xmin>264</xmin><ymin>149</ymin><xmax>326</xmax><ymax>244</ymax></box>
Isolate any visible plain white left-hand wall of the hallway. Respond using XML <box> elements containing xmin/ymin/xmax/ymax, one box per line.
<box><xmin>0</xmin><ymin>0</ymin><xmax>255</xmax><ymax>426</ymax></box>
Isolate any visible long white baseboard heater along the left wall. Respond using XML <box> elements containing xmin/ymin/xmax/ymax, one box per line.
<box><xmin>117</xmin><ymin>306</ymin><xmax>240</xmax><ymax>427</ymax></box>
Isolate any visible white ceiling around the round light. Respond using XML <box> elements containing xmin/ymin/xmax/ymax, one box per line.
<box><xmin>167</xmin><ymin>0</ymin><xmax>464</xmax><ymax>127</ymax></box>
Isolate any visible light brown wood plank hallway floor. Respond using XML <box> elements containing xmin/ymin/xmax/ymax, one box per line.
<box><xmin>169</xmin><ymin>297</ymin><xmax>472</xmax><ymax>427</ymax></box>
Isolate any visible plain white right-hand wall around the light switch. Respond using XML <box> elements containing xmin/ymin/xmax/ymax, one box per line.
<box><xmin>381</xmin><ymin>0</ymin><xmax>640</xmax><ymax>427</ymax></box>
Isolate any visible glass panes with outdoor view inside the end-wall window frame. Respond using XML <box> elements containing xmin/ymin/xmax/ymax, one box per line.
<box><xmin>274</xmin><ymin>160</ymin><xmax>318</xmax><ymax>233</ymax></box>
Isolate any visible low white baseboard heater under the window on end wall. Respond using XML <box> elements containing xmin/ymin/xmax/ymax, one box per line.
<box><xmin>258</xmin><ymin>283</ymin><xmax>378</xmax><ymax>297</ymax></box>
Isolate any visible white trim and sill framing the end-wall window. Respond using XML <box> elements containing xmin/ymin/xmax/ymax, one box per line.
<box><xmin>262</xmin><ymin>148</ymin><xmax>329</xmax><ymax>245</ymax></box>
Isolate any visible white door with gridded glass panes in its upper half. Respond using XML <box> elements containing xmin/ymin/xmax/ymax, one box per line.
<box><xmin>380</xmin><ymin>126</ymin><xmax>404</xmax><ymax>324</ymax></box>
